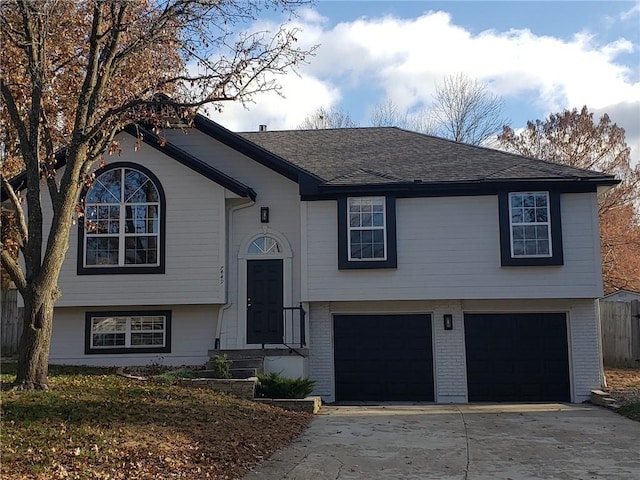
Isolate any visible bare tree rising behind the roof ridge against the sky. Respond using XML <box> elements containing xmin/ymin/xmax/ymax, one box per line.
<box><xmin>432</xmin><ymin>73</ymin><xmax>509</xmax><ymax>145</ymax></box>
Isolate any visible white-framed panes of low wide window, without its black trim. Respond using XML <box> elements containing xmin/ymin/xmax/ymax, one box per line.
<box><xmin>90</xmin><ymin>315</ymin><xmax>167</xmax><ymax>350</ymax></box>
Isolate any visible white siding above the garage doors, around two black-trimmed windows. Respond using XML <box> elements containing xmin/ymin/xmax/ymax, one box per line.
<box><xmin>303</xmin><ymin>194</ymin><xmax>602</xmax><ymax>301</ymax></box>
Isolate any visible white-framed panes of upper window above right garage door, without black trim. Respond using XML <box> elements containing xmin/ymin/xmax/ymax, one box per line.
<box><xmin>509</xmin><ymin>192</ymin><xmax>553</xmax><ymax>258</ymax></box>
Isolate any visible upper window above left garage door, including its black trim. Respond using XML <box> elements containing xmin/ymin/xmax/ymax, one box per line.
<box><xmin>338</xmin><ymin>196</ymin><xmax>397</xmax><ymax>269</ymax></box>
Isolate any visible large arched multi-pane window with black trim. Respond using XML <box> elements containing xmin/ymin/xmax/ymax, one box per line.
<box><xmin>78</xmin><ymin>163</ymin><xmax>164</xmax><ymax>273</ymax></box>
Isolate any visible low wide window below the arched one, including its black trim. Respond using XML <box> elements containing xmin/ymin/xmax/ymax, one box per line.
<box><xmin>85</xmin><ymin>311</ymin><xmax>171</xmax><ymax>354</ymax></box>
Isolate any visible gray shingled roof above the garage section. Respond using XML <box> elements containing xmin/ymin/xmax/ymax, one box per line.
<box><xmin>238</xmin><ymin>127</ymin><xmax>613</xmax><ymax>186</ymax></box>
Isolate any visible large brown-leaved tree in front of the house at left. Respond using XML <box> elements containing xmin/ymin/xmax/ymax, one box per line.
<box><xmin>0</xmin><ymin>0</ymin><xmax>313</xmax><ymax>389</ymax></box>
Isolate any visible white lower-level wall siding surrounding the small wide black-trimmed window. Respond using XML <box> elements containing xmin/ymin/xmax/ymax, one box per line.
<box><xmin>49</xmin><ymin>305</ymin><xmax>218</xmax><ymax>366</ymax></box>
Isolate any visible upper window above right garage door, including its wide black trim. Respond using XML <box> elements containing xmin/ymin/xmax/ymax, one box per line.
<box><xmin>499</xmin><ymin>191</ymin><xmax>563</xmax><ymax>266</ymax></box>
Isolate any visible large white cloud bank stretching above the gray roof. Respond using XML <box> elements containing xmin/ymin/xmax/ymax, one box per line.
<box><xmin>208</xmin><ymin>4</ymin><xmax>640</xmax><ymax>158</ymax></box>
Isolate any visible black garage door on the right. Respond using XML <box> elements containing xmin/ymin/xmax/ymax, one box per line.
<box><xmin>464</xmin><ymin>313</ymin><xmax>570</xmax><ymax>402</ymax></box>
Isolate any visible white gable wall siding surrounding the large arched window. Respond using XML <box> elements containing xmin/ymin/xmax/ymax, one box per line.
<box><xmin>57</xmin><ymin>134</ymin><xmax>225</xmax><ymax>306</ymax></box>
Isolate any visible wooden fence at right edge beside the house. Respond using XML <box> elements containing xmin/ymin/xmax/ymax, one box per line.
<box><xmin>600</xmin><ymin>300</ymin><xmax>640</xmax><ymax>367</ymax></box>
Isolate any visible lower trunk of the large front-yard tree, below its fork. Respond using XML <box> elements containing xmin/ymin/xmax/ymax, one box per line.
<box><xmin>13</xmin><ymin>288</ymin><xmax>57</xmax><ymax>390</ymax></box>
